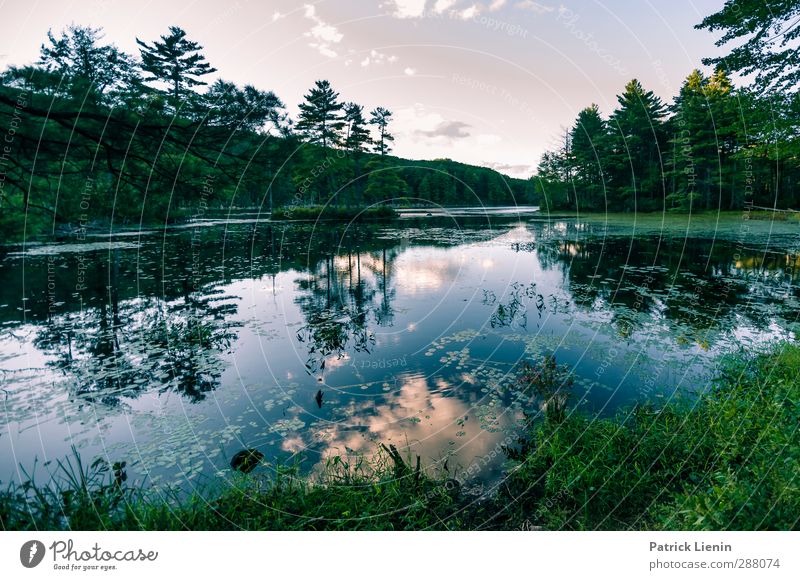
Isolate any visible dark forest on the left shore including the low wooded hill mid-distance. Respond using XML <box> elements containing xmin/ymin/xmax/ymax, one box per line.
<box><xmin>0</xmin><ymin>25</ymin><xmax>536</xmax><ymax>239</ymax></box>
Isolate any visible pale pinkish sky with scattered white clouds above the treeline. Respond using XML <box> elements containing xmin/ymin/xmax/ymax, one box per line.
<box><xmin>0</xmin><ymin>0</ymin><xmax>724</xmax><ymax>177</ymax></box>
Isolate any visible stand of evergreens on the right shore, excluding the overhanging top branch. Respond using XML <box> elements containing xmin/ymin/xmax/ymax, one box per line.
<box><xmin>534</xmin><ymin>68</ymin><xmax>800</xmax><ymax>211</ymax></box>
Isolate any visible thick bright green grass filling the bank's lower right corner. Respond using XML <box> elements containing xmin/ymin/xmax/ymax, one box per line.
<box><xmin>499</xmin><ymin>344</ymin><xmax>800</xmax><ymax>530</ymax></box>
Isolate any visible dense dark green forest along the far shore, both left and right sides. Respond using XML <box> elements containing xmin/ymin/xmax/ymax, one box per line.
<box><xmin>0</xmin><ymin>0</ymin><xmax>800</xmax><ymax>240</ymax></box>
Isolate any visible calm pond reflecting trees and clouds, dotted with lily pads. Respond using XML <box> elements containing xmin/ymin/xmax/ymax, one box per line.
<box><xmin>0</xmin><ymin>209</ymin><xmax>800</xmax><ymax>488</ymax></box>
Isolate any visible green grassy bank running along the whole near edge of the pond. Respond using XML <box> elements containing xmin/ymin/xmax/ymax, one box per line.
<box><xmin>0</xmin><ymin>344</ymin><xmax>800</xmax><ymax>530</ymax></box>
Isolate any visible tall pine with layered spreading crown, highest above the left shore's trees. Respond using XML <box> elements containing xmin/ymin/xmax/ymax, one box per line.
<box><xmin>136</xmin><ymin>26</ymin><xmax>217</xmax><ymax>106</ymax></box>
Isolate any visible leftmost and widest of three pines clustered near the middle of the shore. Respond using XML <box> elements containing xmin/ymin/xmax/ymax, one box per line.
<box><xmin>296</xmin><ymin>80</ymin><xmax>345</xmax><ymax>147</ymax></box>
